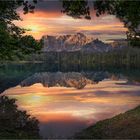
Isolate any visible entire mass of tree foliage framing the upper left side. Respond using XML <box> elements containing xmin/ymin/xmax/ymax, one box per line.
<box><xmin>0</xmin><ymin>0</ymin><xmax>41</xmax><ymax>60</ymax></box>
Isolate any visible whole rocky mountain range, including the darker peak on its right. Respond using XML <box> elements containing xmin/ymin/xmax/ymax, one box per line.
<box><xmin>42</xmin><ymin>33</ymin><xmax>118</xmax><ymax>52</ymax></box>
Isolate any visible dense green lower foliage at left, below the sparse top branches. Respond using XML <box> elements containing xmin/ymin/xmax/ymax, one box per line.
<box><xmin>0</xmin><ymin>21</ymin><xmax>42</xmax><ymax>61</ymax></box>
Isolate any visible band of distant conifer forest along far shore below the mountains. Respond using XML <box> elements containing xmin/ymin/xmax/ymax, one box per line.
<box><xmin>26</xmin><ymin>48</ymin><xmax>140</xmax><ymax>70</ymax></box>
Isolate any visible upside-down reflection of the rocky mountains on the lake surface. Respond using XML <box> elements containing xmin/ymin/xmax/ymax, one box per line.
<box><xmin>20</xmin><ymin>72</ymin><xmax>109</xmax><ymax>89</ymax></box>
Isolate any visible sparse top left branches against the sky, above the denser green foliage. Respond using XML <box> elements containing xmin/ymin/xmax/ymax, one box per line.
<box><xmin>0</xmin><ymin>0</ymin><xmax>37</xmax><ymax>36</ymax></box>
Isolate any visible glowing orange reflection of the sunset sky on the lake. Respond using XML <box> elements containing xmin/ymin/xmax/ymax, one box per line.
<box><xmin>3</xmin><ymin>80</ymin><xmax>140</xmax><ymax>122</ymax></box>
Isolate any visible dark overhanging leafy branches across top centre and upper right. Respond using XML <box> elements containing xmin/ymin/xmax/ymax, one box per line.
<box><xmin>62</xmin><ymin>0</ymin><xmax>140</xmax><ymax>46</ymax></box>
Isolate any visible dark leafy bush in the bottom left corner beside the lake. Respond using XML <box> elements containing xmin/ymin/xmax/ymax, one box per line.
<box><xmin>0</xmin><ymin>96</ymin><xmax>40</xmax><ymax>139</ymax></box>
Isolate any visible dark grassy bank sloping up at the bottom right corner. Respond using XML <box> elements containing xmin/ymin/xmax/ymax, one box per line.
<box><xmin>74</xmin><ymin>106</ymin><xmax>140</xmax><ymax>139</ymax></box>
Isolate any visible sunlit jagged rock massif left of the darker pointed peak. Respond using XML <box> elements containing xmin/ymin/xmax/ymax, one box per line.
<box><xmin>42</xmin><ymin>33</ymin><xmax>93</xmax><ymax>52</ymax></box>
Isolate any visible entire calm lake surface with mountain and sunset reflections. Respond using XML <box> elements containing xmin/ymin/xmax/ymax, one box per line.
<box><xmin>0</xmin><ymin>64</ymin><xmax>140</xmax><ymax>138</ymax></box>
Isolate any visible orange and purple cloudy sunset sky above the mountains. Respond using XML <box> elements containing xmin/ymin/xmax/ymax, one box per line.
<box><xmin>15</xmin><ymin>1</ymin><xmax>126</xmax><ymax>41</ymax></box>
